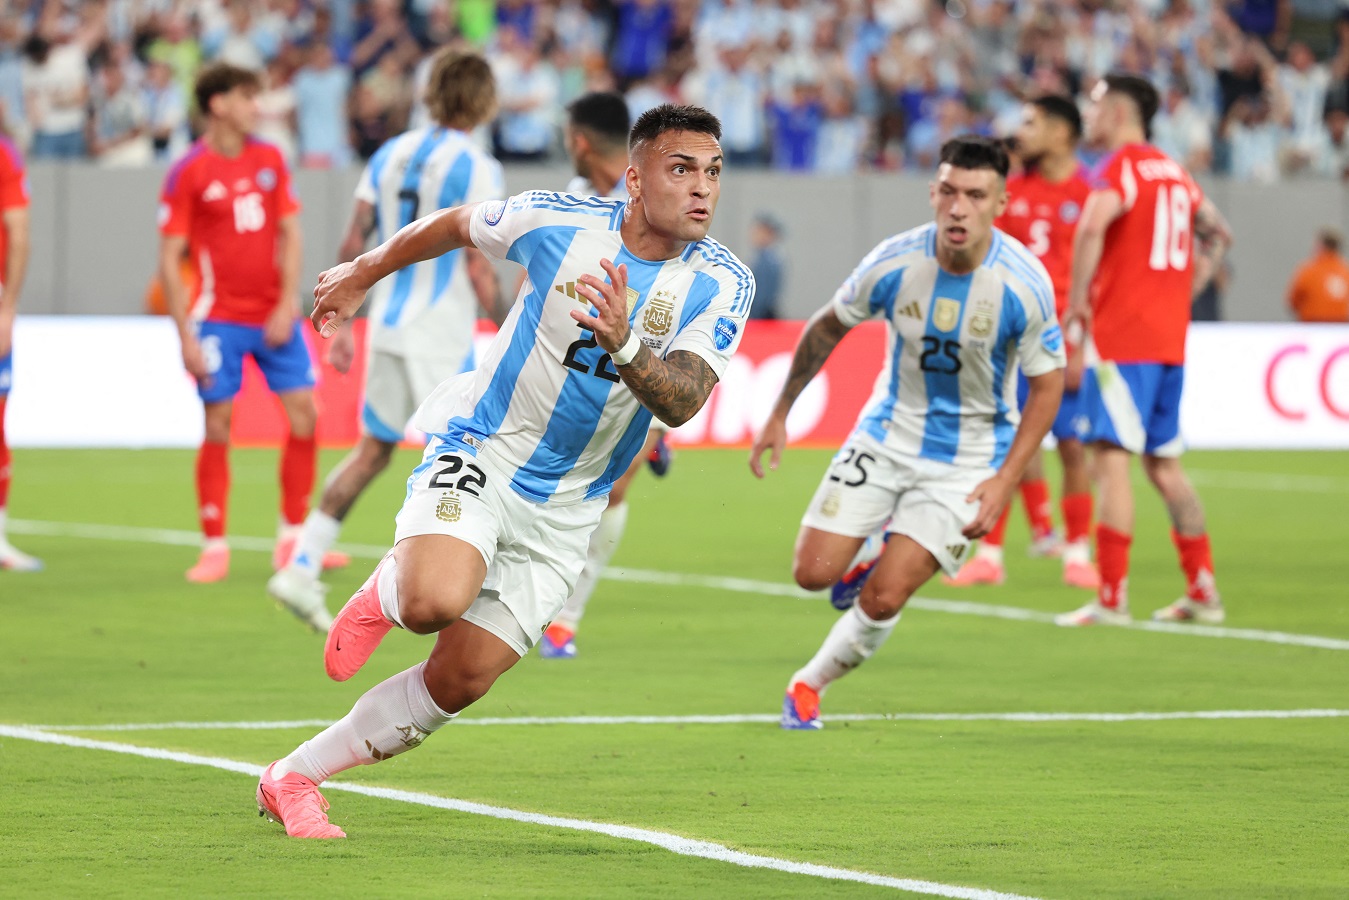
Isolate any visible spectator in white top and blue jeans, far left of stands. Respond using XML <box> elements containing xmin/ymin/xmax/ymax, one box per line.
<box><xmin>23</xmin><ymin>34</ymin><xmax>89</xmax><ymax>159</ymax></box>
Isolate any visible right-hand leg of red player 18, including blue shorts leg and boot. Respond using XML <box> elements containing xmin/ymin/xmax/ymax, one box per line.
<box><xmin>1143</xmin><ymin>366</ymin><xmax>1226</xmax><ymax>625</ymax></box>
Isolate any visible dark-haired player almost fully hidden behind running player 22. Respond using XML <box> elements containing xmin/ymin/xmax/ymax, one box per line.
<box><xmin>538</xmin><ymin>92</ymin><xmax>670</xmax><ymax>660</ymax></box>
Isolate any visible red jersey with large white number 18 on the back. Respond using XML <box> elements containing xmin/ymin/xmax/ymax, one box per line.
<box><xmin>1091</xmin><ymin>144</ymin><xmax>1203</xmax><ymax>364</ymax></box>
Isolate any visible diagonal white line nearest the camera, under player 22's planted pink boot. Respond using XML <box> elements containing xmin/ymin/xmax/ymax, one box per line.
<box><xmin>0</xmin><ymin>725</ymin><xmax>1035</xmax><ymax>900</ymax></box>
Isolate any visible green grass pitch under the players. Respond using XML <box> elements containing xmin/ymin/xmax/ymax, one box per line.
<box><xmin>0</xmin><ymin>451</ymin><xmax>1349</xmax><ymax>899</ymax></box>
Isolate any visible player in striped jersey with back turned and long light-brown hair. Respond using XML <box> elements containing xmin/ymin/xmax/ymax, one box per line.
<box><xmin>267</xmin><ymin>50</ymin><xmax>507</xmax><ymax>618</ymax></box>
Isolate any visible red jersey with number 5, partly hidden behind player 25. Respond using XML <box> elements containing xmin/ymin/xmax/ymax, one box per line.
<box><xmin>996</xmin><ymin>167</ymin><xmax>1091</xmax><ymax>318</ymax></box>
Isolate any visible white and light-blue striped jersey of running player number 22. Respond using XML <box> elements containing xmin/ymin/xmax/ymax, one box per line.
<box><xmin>414</xmin><ymin>192</ymin><xmax>754</xmax><ymax>502</ymax></box>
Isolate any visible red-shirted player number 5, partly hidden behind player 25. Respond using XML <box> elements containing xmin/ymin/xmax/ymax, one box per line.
<box><xmin>948</xmin><ymin>96</ymin><xmax>1101</xmax><ymax>590</ymax></box>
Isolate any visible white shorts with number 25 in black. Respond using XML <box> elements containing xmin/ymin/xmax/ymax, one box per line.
<box><xmin>801</xmin><ymin>434</ymin><xmax>996</xmax><ymax>575</ymax></box>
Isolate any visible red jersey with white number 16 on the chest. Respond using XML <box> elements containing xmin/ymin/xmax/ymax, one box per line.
<box><xmin>159</xmin><ymin>138</ymin><xmax>299</xmax><ymax>325</ymax></box>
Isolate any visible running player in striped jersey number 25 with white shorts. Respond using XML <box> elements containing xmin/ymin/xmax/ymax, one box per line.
<box><xmin>750</xmin><ymin>136</ymin><xmax>1064</xmax><ymax>730</ymax></box>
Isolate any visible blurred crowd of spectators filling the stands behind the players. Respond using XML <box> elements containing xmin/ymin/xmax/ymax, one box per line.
<box><xmin>0</xmin><ymin>0</ymin><xmax>1349</xmax><ymax>182</ymax></box>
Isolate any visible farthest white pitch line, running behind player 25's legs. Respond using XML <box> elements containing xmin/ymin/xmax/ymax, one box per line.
<box><xmin>9</xmin><ymin>519</ymin><xmax>1349</xmax><ymax>650</ymax></box>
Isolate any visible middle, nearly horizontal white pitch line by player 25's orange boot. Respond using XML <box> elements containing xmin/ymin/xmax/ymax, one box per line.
<box><xmin>26</xmin><ymin>710</ymin><xmax>1349</xmax><ymax>733</ymax></box>
